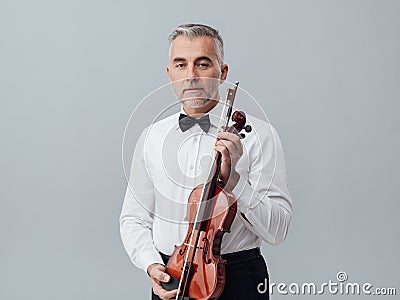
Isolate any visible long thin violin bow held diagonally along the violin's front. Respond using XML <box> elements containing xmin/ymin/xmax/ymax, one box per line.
<box><xmin>175</xmin><ymin>89</ymin><xmax>229</xmax><ymax>300</ymax></box>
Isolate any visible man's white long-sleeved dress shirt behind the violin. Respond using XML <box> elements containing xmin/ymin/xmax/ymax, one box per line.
<box><xmin>120</xmin><ymin>104</ymin><xmax>292</xmax><ymax>271</ymax></box>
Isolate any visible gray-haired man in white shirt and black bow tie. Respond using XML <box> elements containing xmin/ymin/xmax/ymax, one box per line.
<box><xmin>120</xmin><ymin>24</ymin><xmax>292</xmax><ymax>299</ymax></box>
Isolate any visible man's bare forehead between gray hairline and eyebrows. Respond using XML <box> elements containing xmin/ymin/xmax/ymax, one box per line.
<box><xmin>170</xmin><ymin>35</ymin><xmax>217</xmax><ymax>60</ymax></box>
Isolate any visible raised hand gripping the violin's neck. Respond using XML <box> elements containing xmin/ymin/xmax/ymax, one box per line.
<box><xmin>215</xmin><ymin>132</ymin><xmax>243</xmax><ymax>190</ymax></box>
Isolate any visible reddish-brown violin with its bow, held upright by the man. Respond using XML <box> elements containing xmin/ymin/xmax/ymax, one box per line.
<box><xmin>162</xmin><ymin>82</ymin><xmax>251</xmax><ymax>300</ymax></box>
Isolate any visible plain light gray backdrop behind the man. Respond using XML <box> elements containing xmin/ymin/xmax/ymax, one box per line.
<box><xmin>0</xmin><ymin>0</ymin><xmax>400</xmax><ymax>300</ymax></box>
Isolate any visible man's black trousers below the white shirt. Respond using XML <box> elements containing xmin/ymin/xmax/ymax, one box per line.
<box><xmin>152</xmin><ymin>248</ymin><xmax>269</xmax><ymax>300</ymax></box>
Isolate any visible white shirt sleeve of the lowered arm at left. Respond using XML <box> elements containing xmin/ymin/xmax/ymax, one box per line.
<box><xmin>119</xmin><ymin>131</ymin><xmax>163</xmax><ymax>272</ymax></box>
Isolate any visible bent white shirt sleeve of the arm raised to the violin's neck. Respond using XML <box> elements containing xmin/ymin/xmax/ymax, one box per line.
<box><xmin>233</xmin><ymin>125</ymin><xmax>292</xmax><ymax>245</ymax></box>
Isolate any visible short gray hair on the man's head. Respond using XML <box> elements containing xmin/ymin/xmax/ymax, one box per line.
<box><xmin>168</xmin><ymin>24</ymin><xmax>224</xmax><ymax>65</ymax></box>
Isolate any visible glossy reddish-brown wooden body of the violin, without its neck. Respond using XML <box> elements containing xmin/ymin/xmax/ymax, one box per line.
<box><xmin>167</xmin><ymin>185</ymin><xmax>237</xmax><ymax>299</ymax></box>
